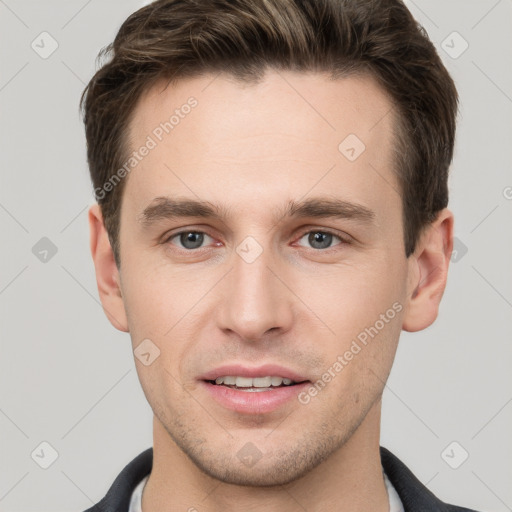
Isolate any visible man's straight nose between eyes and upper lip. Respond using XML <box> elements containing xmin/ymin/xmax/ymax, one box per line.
<box><xmin>217</xmin><ymin>241</ymin><xmax>293</xmax><ymax>342</ymax></box>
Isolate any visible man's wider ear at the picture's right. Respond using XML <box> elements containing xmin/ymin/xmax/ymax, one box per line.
<box><xmin>402</xmin><ymin>208</ymin><xmax>453</xmax><ymax>332</ymax></box>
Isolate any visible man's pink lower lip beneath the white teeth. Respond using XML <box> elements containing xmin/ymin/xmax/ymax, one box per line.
<box><xmin>201</xmin><ymin>381</ymin><xmax>310</xmax><ymax>414</ymax></box>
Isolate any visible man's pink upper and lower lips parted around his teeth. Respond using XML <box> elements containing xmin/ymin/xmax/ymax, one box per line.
<box><xmin>198</xmin><ymin>364</ymin><xmax>311</xmax><ymax>415</ymax></box>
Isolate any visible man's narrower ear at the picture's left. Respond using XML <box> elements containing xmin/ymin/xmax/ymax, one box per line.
<box><xmin>89</xmin><ymin>204</ymin><xmax>129</xmax><ymax>332</ymax></box>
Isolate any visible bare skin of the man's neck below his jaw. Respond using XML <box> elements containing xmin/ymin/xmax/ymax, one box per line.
<box><xmin>142</xmin><ymin>401</ymin><xmax>389</xmax><ymax>512</ymax></box>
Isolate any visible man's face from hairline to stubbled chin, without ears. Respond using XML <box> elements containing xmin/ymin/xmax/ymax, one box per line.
<box><xmin>115</xmin><ymin>71</ymin><xmax>411</xmax><ymax>485</ymax></box>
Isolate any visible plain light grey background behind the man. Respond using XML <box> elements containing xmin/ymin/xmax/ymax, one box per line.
<box><xmin>0</xmin><ymin>0</ymin><xmax>512</xmax><ymax>512</ymax></box>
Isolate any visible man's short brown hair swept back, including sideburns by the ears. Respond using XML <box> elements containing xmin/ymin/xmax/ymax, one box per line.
<box><xmin>80</xmin><ymin>0</ymin><xmax>458</xmax><ymax>267</ymax></box>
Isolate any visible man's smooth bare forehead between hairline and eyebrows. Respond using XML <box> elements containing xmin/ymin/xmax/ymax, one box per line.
<box><xmin>123</xmin><ymin>70</ymin><xmax>399</xmax><ymax>224</ymax></box>
